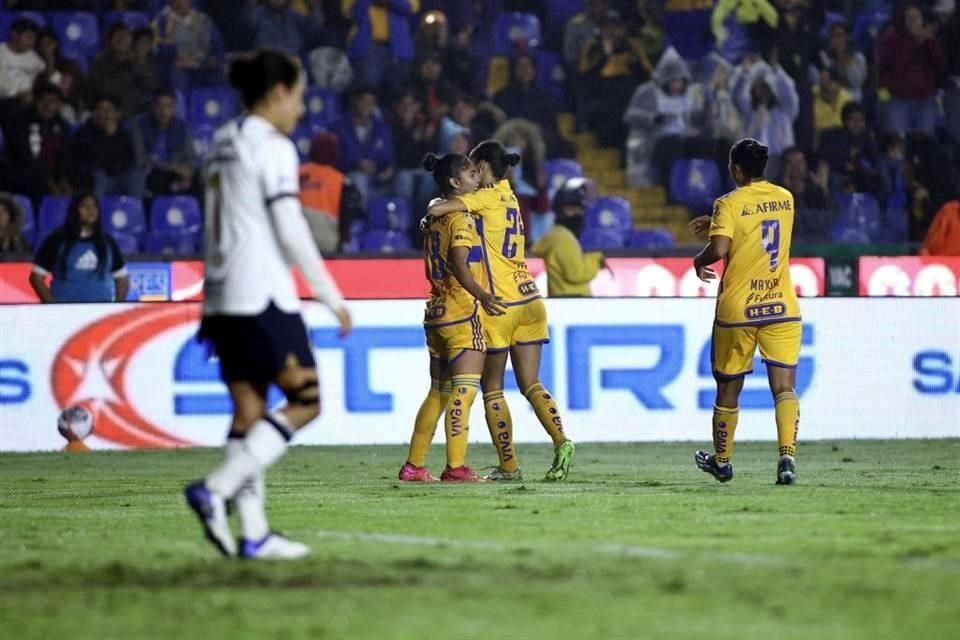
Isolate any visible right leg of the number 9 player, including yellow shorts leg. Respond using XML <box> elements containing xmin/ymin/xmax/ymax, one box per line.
<box><xmin>759</xmin><ymin>322</ymin><xmax>803</xmax><ymax>484</ymax></box>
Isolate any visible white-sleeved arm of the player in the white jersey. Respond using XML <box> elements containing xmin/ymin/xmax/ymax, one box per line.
<box><xmin>264</xmin><ymin>141</ymin><xmax>352</xmax><ymax>336</ymax></box>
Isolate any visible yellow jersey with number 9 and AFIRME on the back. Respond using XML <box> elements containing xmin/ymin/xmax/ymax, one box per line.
<box><xmin>710</xmin><ymin>180</ymin><xmax>800</xmax><ymax>326</ymax></box>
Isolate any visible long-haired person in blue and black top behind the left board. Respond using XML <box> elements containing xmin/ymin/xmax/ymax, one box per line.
<box><xmin>30</xmin><ymin>192</ymin><xmax>130</xmax><ymax>302</ymax></box>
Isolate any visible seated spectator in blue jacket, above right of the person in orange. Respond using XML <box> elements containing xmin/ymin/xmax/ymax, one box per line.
<box><xmin>331</xmin><ymin>85</ymin><xmax>396</xmax><ymax>202</ymax></box>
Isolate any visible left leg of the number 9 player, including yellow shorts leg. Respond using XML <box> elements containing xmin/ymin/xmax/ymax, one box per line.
<box><xmin>694</xmin><ymin>326</ymin><xmax>757</xmax><ymax>482</ymax></box>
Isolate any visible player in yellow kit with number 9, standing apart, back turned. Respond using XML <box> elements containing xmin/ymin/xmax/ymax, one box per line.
<box><xmin>690</xmin><ymin>138</ymin><xmax>802</xmax><ymax>484</ymax></box>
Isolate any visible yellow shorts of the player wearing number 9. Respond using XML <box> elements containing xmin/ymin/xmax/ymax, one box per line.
<box><xmin>710</xmin><ymin>322</ymin><xmax>803</xmax><ymax>380</ymax></box>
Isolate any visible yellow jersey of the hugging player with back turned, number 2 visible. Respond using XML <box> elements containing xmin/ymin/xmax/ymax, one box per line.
<box><xmin>456</xmin><ymin>180</ymin><xmax>540</xmax><ymax>305</ymax></box>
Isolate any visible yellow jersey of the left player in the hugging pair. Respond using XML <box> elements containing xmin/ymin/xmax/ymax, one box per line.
<box><xmin>423</xmin><ymin>212</ymin><xmax>490</xmax><ymax>324</ymax></box>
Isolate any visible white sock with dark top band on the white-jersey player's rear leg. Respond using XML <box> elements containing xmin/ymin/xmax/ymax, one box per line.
<box><xmin>212</xmin><ymin>413</ymin><xmax>293</xmax><ymax>500</ymax></box>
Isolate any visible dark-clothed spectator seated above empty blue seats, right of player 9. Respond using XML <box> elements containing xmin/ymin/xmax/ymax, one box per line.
<box><xmin>817</xmin><ymin>102</ymin><xmax>883</xmax><ymax>198</ymax></box>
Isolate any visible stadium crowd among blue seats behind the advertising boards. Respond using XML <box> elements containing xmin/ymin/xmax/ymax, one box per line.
<box><xmin>0</xmin><ymin>0</ymin><xmax>960</xmax><ymax>256</ymax></box>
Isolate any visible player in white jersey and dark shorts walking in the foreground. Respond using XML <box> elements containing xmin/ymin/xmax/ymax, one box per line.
<box><xmin>185</xmin><ymin>49</ymin><xmax>351</xmax><ymax>559</ymax></box>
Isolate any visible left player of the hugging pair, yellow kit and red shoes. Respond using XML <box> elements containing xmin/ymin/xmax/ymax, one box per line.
<box><xmin>399</xmin><ymin>154</ymin><xmax>504</xmax><ymax>482</ymax></box>
